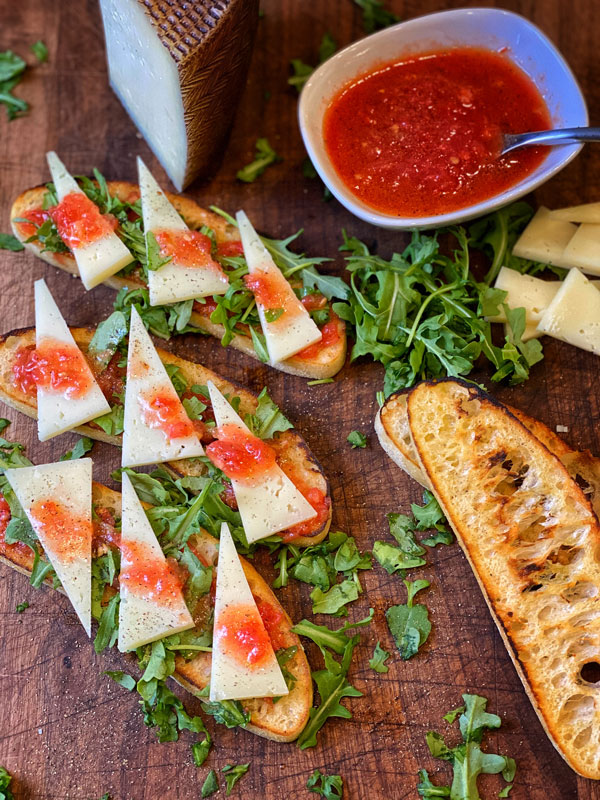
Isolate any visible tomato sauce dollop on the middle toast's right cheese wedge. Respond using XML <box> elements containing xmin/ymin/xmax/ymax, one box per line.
<box><xmin>206</xmin><ymin>424</ymin><xmax>275</xmax><ymax>484</ymax></box>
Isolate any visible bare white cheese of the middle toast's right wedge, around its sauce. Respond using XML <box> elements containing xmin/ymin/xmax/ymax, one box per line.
<box><xmin>208</xmin><ymin>381</ymin><xmax>317</xmax><ymax>543</ymax></box>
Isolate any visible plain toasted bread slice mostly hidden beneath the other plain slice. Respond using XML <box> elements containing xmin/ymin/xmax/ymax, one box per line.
<box><xmin>375</xmin><ymin>389</ymin><xmax>600</xmax><ymax>518</ymax></box>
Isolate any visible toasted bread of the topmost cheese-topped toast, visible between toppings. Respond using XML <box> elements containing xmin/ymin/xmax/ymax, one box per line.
<box><xmin>10</xmin><ymin>186</ymin><xmax>346</xmax><ymax>379</ymax></box>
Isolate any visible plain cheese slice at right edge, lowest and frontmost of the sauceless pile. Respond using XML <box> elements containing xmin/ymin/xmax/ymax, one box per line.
<box><xmin>538</xmin><ymin>269</ymin><xmax>600</xmax><ymax>355</ymax></box>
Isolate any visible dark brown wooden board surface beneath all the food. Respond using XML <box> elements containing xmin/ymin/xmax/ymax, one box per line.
<box><xmin>0</xmin><ymin>0</ymin><xmax>600</xmax><ymax>800</ymax></box>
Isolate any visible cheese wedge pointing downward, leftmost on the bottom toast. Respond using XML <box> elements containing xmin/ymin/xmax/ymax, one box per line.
<box><xmin>4</xmin><ymin>458</ymin><xmax>92</xmax><ymax>636</ymax></box>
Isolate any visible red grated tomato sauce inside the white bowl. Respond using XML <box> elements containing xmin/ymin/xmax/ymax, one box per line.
<box><xmin>323</xmin><ymin>48</ymin><xmax>551</xmax><ymax>217</ymax></box>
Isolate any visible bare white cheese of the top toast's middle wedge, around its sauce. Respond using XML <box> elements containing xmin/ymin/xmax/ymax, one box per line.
<box><xmin>137</xmin><ymin>157</ymin><xmax>229</xmax><ymax>306</ymax></box>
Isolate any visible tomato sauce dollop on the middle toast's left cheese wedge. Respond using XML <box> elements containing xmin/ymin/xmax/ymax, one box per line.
<box><xmin>12</xmin><ymin>339</ymin><xmax>94</xmax><ymax>398</ymax></box>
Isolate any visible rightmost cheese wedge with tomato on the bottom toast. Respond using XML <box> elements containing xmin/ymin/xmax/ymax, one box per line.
<box><xmin>210</xmin><ymin>522</ymin><xmax>289</xmax><ymax>702</ymax></box>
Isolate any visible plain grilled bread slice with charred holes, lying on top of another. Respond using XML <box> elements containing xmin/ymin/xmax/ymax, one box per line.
<box><xmin>408</xmin><ymin>379</ymin><xmax>600</xmax><ymax>779</ymax></box>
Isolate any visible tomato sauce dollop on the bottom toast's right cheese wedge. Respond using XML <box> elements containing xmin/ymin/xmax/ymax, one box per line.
<box><xmin>215</xmin><ymin>605</ymin><xmax>272</xmax><ymax>668</ymax></box>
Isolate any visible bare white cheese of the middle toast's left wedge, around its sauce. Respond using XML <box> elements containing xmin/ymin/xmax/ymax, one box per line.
<box><xmin>34</xmin><ymin>279</ymin><xmax>110</xmax><ymax>442</ymax></box>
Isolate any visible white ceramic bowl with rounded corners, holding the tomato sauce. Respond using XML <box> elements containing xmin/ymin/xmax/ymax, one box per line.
<box><xmin>298</xmin><ymin>8</ymin><xmax>588</xmax><ymax>230</ymax></box>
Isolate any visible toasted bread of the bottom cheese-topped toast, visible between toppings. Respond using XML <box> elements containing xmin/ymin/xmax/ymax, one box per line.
<box><xmin>0</xmin><ymin>483</ymin><xmax>313</xmax><ymax>742</ymax></box>
